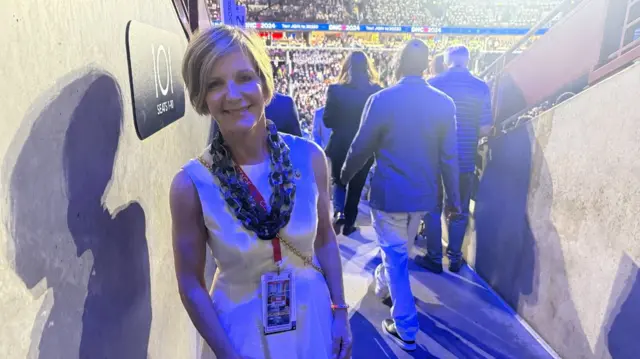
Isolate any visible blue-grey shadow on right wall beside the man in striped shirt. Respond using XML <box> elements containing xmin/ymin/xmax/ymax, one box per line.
<box><xmin>474</xmin><ymin>122</ymin><xmax>538</xmax><ymax>308</ymax></box>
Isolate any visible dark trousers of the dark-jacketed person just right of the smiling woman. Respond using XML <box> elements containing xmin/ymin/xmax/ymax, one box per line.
<box><xmin>331</xmin><ymin>158</ymin><xmax>373</xmax><ymax>226</ymax></box>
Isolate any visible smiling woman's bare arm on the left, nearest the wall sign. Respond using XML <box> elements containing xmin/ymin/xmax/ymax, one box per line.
<box><xmin>170</xmin><ymin>171</ymin><xmax>239</xmax><ymax>359</ymax></box>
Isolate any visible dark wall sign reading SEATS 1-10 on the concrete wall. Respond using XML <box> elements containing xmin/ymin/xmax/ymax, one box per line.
<box><xmin>127</xmin><ymin>21</ymin><xmax>185</xmax><ymax>140</ymax></box>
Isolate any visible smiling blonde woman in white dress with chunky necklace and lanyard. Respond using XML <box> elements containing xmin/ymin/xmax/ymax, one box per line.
<box><xmin>170</xmin><ymin>26</ymin><xmax>351</xmax><ymax>359</ymax></box>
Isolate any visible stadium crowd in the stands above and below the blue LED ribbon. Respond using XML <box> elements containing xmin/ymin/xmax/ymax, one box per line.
<box><xmin>206</xmin><ymin>0</ymin><xmax>562</xmax><ymax>128</ymax></box>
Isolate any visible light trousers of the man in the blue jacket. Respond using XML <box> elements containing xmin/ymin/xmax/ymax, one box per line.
<box><xmin>371</xmin><ymin>209</ymin><xmax>426</xmax><ymax>341</ymax></box>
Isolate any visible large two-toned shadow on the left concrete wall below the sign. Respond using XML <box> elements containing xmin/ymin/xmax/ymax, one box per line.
<box><xmin>4</xmin><ymin>71</ymin><xmax>152</xmax><ymax>359</ymax></box>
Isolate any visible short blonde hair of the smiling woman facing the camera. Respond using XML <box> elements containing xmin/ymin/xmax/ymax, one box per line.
<box><xmin>182</xmin><ymin>25</ymin><xmax>274</xmax><ymax>115</ymax></box>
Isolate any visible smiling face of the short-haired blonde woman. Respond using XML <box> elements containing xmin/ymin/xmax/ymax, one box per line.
<box><xmin>206</xmin><ymin>50</ymin><xmax>265</xmax><ymax>133</ymax></box>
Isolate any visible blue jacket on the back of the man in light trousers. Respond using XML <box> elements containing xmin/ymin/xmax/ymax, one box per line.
<box><xmin>343</xmin><ymin>77</ymin><xmax>458</xmax><ymax>212</ymax></box>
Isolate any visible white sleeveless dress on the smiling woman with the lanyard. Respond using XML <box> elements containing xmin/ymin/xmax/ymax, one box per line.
<box><xmin>183</xmin><ymin>133</ymin><xmax>333</xmax><ymax>359</ymax></box>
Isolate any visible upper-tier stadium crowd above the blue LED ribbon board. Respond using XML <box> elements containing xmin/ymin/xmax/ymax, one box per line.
<box><xmin>206</xmin><ymin>0</ymin><xmax>562</xmax><ymax>27</ymax></box>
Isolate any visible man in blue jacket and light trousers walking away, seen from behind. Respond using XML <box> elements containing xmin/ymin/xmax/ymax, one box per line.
<box><xmin>341</xmin><ymin>39</ymin><xmax>460</xmax><ymax>350</ymax></box>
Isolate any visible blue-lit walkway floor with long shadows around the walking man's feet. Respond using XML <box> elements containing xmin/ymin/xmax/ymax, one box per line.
<box><xmin>338</xmin><ymin>203</ymin><xmax>558</xmax><ymax>359</ymax></box>
